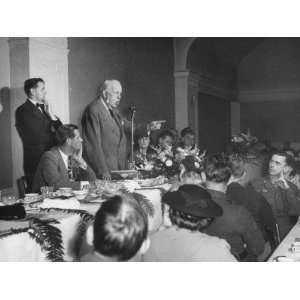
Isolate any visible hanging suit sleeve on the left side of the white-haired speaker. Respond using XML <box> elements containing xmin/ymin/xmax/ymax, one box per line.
<box><xmin>82</xmin><ymin>110</ymin><xmax>109</xmax><ymax>177</ymax></box>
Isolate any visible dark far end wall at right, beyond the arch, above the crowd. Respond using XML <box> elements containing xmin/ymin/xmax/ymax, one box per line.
<box><xmin>238</xmin><ymin>38</ymin><xmax>300</xmax><ymax>143</ymax></box>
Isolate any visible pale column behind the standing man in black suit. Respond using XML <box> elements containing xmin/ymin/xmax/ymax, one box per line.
<box><xmin>9</xmin><ymin>38</ymin><xmax>70</xmax><ymax>187</ymax></box>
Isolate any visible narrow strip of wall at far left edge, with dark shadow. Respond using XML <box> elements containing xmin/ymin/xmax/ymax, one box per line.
<box><xmin>0</xmin><ymin>37</ymin><xmax>12</xmax><ymax>189</ymax></box>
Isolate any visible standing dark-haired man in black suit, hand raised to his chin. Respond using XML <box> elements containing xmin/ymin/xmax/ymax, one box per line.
<box><xmin>16</xmin><ymin>78</ymin><xmax>61</xmax><ymax>191</ymax></box>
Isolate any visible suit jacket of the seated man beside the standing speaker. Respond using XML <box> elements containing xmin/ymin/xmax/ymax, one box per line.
<box><xmin>32</xmin><ymin>147</ymin><xmax>96</xmax><ymax>192</ymax></box>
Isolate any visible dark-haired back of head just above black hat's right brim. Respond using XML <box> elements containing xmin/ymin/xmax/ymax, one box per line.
<box><xmin>205</xmin><ymin>156</ymin><xmax>231</xmax><ymax>183</ymax></box>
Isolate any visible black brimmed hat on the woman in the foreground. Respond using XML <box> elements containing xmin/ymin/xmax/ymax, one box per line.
<box><xmin>162</xmin><ymin>184</ymin><xmax>223</xmax><ymax>218</ymax></box>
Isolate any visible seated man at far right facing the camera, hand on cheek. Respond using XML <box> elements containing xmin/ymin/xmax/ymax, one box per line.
<box><xmin>252</xmin><ymin>151</ymin><xmax>300</xmax><ymax>239</ymax></box>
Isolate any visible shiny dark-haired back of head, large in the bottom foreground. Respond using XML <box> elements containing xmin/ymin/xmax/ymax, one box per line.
<box><xmin>93</xmin><ymin>195</ymin><xmax>148</xmax><ymax>261</ymax></box>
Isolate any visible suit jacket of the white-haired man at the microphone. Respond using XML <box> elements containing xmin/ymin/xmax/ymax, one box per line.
<box><xmin>82</xmin><ymin>99</ymin><xmax>128</xmax><ymax>177</ymax></box>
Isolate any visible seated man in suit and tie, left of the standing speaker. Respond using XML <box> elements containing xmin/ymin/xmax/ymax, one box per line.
<box><xmin>33</xmin><ymin>124</ymin><xmax>96</xmax><ymax>192</ymax></box>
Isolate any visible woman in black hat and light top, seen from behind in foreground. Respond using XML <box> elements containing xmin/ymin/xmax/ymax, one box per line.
<box><xmin>144</xmin><ymin>184</ymin><xmax>236</xmax><ymax>261</ymax></box>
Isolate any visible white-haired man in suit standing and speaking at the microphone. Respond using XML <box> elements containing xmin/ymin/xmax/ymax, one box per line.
<box><xmin>82</xmin><ymin>80</ymin><xmax>161</xmax><ymax>180</ymax></box>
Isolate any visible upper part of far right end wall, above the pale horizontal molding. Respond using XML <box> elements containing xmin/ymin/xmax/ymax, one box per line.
<box><xmin>238</xmin><ymin>38</ymin><xmax>300</xmax><ymax>92</ymax></box>
